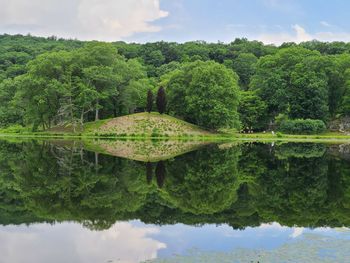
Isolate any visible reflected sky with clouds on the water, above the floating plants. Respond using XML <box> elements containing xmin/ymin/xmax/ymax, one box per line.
<box><xmin>0</xmin><ymin>221</ymin><xmax>350</xmax><ymax>263</ymax></box>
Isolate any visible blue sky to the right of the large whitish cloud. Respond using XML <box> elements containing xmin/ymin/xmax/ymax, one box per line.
<box><xmin>130</xmin><ymin>0</ymin><xmax>350</xmax><ymax>43</ymax></box>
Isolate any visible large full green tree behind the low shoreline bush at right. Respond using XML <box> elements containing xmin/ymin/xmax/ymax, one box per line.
<box><xmin>251</xmin><ymin>47</ymin><xmax>330</xmax><ymax>120</ymax></box>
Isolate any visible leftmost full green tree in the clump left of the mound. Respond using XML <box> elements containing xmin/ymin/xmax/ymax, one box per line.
<box><xmin>14</xmin><ymin>51</ymin><xmax>71</xmax><ymax>129</ymax></box>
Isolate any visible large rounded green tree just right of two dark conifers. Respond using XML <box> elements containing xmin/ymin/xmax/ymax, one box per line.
<box><xmin>167</xmin><ymin>61</ymin><xmax>239</xmax><ymax>129</ymax></box>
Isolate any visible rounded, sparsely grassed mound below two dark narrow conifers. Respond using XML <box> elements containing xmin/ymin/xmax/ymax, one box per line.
<box><xmin>85</xmin><ymin>112</ymin><xmax>211</xmax><ymax>137</ymax></box>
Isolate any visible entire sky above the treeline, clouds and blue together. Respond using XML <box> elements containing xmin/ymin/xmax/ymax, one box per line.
<box><xmin>0</xmin><ymin>0</ymin><xmax>350</xmax><ymax>45</ymax></box>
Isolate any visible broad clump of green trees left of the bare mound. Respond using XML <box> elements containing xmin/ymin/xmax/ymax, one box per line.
<box><xmin>8</xmin><ymin>42</ymin><xmax>149</xmax><ymax>129</ymax></box>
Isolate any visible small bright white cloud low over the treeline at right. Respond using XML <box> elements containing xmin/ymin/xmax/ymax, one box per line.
<box><xmin>255</xmin><ymin>24</ymin><xmax>350</xmax><ymax>45</ymax></box>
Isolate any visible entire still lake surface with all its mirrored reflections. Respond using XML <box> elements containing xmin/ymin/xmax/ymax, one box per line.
<box><xmin>0</xmin><ymin>140</ymin><xmax>350</xmax><ymax>263</ymax></box>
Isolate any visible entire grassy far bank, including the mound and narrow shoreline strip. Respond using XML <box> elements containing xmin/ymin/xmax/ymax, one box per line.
<box><xmin>0</xmin><ymin>112</ymin><xmax>350</xmax><ymax>143</ymax></box>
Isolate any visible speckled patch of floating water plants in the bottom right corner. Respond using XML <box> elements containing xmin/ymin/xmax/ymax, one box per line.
<box><xmin>151</xmin><ymin>234</ymin><xmax>350</xmax><ymax>263</ymax></box>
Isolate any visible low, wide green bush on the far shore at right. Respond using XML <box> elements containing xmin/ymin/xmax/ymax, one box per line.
<box><xmin>278</xmin><ymin>119</ymin><xmax>326</xmax><ymax>134</ymax></box>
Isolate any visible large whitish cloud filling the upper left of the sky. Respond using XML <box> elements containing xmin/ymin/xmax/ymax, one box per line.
<box><xmin>0</xmin><ymin>0</ymin><xmax>168</xmax><ymax>41</ymax></box>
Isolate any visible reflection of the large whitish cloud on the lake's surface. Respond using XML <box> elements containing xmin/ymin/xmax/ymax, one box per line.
<box><xmin>0</xmin><ymin>222</ymin><xmax>166</xmax><ymax>263</ymax></box>
